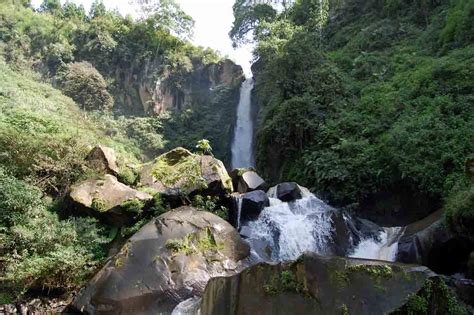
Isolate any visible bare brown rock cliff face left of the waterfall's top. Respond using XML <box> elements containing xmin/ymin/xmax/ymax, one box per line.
<box><xmin>116</xmin><ymin>59</ymin><xmax>244</xmax><ymax>115</ymax></box>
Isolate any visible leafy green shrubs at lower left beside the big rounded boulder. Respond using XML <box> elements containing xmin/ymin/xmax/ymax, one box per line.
<box><xmin>0</xmin><ymin>168</ymin><xmax>108</xmax><ymax>294</ymax></box>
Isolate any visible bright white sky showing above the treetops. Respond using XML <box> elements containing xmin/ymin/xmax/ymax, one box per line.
<box><xmin>32</xmin><ymin>0</ymin><xmax>252</xmax><ymax>76</ymax></box>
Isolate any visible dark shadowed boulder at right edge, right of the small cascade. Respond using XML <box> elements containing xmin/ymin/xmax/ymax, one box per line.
<box><xmin>397</xmin><ymin>210</ymin><xmax>474</xmax><ymax>274</ymax></box>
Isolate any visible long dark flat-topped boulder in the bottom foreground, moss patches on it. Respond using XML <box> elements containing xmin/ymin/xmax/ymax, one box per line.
<box><xmin>201</xmin><ymin>253</ymin><xmax>466</xmax><ymax>315</ymax></box>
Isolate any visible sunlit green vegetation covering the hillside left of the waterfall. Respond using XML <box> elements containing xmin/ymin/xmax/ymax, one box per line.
<box><xmin>0</xmin><ymin>0</ymin><xmax>239</xmax><ymax>304</ymax></box>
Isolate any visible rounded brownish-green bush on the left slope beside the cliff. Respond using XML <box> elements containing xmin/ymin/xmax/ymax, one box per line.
<box><xmin>59</xmin><ymin>61</ymin><xmax>114</xmax><ymax>110</ymax></box>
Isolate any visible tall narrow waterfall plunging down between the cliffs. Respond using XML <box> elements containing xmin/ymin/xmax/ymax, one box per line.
<box><xmin>232</xmin><ymin>78</ymin><xmax>254</xmax><ymax>168</ymax></box>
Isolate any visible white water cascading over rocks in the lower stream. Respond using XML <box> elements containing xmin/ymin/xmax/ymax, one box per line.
<box><xmin>241</xmin><ymin>187</ymin><xmax>403</xmax><ymax>261</ymax></box>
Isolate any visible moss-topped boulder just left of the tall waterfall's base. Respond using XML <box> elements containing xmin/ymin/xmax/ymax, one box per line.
<box><xmin>140</xmin><ymin>148</ymin><xmax>233</xmax><ymax>198</ymax></box>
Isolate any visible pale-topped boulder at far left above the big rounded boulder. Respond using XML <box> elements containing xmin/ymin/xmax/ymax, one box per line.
<box><xmin>69</xmin><ymin>174</ymin><xmax>153</xmax><ymax>226</ymax></box>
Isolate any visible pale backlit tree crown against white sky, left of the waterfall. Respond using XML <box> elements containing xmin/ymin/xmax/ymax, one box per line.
<box><xmin>135</xmin><ymin>0</ymin><xmax>194</xmax><ymax>38</ymax></box>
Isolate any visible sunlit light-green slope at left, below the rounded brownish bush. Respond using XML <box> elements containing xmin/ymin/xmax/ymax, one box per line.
<box><xmin>0</xmin><ymin>60</ymin><xmax>141</xmax><ymax>194</ymax></box>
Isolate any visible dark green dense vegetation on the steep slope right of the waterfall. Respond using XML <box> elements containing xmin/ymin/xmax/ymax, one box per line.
<box><xmin>230</xmin><ymin>0</ymin><xmax>474</xmax><ymax>224</ymax></box>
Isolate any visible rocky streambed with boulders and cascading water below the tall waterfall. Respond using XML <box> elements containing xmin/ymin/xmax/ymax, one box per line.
<box><xmin>2</xmin><ymin>147</ymin><xmax>474</xmax><ymax>315</ymax></box>
